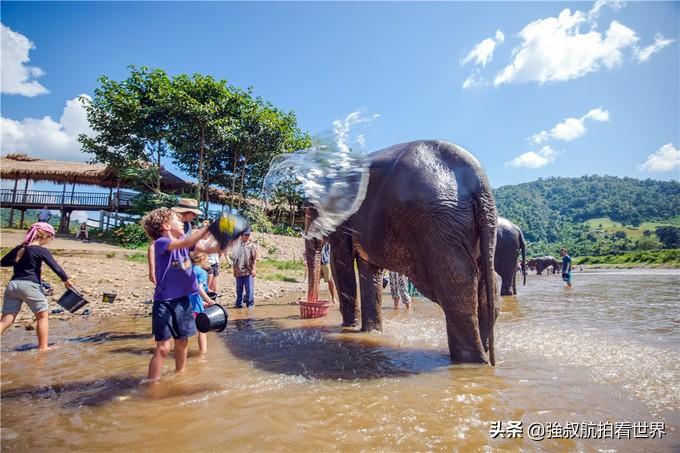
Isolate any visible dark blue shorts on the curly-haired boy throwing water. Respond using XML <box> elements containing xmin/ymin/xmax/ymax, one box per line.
<box><xmin>151</xmin><ymin>296</ymin><xmax>196</xmax><ymax>341</ymax></box>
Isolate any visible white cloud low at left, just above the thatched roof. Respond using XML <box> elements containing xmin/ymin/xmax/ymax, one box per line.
<box><xmin>0</xmin><ymin>94</ymin><xmax>93</xmax><ymax>161</ymax></box>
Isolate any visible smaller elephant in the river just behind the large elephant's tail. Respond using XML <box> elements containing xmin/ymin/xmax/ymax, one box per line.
<box><xmin>493</xmin><ymin>217</ymin><xmax>527</xmax><ymax>296</ymax></box>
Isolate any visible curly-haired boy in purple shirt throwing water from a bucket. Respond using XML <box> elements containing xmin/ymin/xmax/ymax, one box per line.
<box><xmin>141</xmin><ymin>208</ymin><xmax>218</xmax><ymax>381</ymax></box>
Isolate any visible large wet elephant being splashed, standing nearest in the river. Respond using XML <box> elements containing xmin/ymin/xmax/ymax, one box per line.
<box><xmin>304</xmin><ymin>140</ymin><xmax>497</xmax><ymax>365</ymax></box>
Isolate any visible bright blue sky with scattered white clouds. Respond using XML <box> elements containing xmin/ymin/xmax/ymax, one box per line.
<box><xmin>0</xmin><ymin>1</ymin><xmax>680</xmax><ymax>196</ymax></box>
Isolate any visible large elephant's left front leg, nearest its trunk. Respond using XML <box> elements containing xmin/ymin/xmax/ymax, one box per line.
<box><xmin>330</xmin><ymin>235</ymin><xmax>358</xmax><ymax>327</ymax></box>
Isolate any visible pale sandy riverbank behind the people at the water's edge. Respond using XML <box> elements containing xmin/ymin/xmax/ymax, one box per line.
<box><xmin>0</xmin><ymin>230</ymin><xmax>307</xmax><ymax>326</ymax></box>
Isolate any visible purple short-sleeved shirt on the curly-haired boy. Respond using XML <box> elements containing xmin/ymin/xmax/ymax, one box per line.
<box><xmin>153</xmin><ymin>236</ymin><xmax>198</xmax><ymax>301</ymax></box>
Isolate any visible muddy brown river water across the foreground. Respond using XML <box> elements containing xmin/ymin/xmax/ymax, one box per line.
<box><xmin>1</xmin><ymin>270</ymin><xmax>680</xmax><ymax>451</ymax></box>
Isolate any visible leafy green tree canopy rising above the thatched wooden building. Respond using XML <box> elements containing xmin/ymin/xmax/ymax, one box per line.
<box><xmin>78</xmin><ymin>66</ymin><xmax>310</xmax><ymax>212</ymax></box>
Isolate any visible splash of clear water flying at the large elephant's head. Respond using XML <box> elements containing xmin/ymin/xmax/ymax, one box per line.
<box><xmin>264</xmin><ymin>146</ymin><xmax>370</xmax><ymax>239</ymax></box>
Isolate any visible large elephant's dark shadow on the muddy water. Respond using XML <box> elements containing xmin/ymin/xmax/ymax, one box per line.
<box><xmin>219</xmin><ymin>319</ymin><xmax>451</xmax><ymax>380</ymax></box>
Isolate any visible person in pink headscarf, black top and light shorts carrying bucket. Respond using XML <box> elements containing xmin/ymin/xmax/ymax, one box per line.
<box><xmin>0</xmin><ymin>222</ymin><xmax>73</xmax><ymax>351</ymax></box>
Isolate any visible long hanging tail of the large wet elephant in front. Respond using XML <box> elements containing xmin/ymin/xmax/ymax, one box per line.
<box><xmin>475</xmin><ymin>191</ymin><xmax>498</xmax><ymax>366</ymax></box>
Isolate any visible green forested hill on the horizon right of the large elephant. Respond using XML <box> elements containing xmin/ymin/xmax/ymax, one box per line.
<box><xmin>494</xmin><ymin>176</ymin><xmax>680</xmax><ymax>247</ymax></box>
